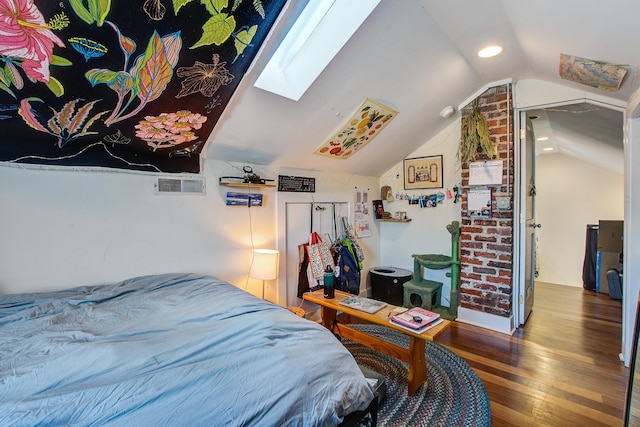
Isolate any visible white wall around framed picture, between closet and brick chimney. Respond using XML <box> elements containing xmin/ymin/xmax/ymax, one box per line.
<box><xmin>376</xmin><ymin>122</ymin><xmax>460</xmax><ymax>306</ymax></box>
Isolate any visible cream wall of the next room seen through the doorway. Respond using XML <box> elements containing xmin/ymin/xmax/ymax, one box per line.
<box><xmin>536</xmin><ymin>153</ymin><xmax>624</xmax><ymax>287</ymax></box>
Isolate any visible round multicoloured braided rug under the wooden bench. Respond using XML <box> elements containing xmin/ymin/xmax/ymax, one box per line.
<box><xmin>342</xmin><ymin>324</ymin><xmax>491</xmax><ymax>427</ymax></box>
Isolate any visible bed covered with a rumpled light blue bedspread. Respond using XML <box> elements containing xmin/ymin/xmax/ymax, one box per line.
<box><xmin>0</xmin><ymin>274</ymin><xmax>375</xmax><ymax>426</ymax></box>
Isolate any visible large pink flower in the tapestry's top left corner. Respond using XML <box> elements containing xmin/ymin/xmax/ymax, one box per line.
<box><xmin>0</xmin><ymin>0</ymin><xmax>64</xmax><ymax>83</ymax></box>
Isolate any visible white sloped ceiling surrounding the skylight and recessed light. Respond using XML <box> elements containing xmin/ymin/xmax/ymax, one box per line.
<box><xmin>206</xmin><ymin>0</ymin><xmax>640</xmax><ymax>176</ymax></box>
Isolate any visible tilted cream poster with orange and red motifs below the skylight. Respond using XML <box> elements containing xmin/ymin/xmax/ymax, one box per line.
<box><xmin>314</xmin><ymin>98</ymin><xmax>398</xmax><ymax>159</ymax></box>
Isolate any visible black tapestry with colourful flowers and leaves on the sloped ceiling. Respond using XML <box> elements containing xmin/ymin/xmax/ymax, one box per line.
<box><xmin>0</xmin><ymin>0</ymin><xmax>285</xmax><ymax>173</ymax></box>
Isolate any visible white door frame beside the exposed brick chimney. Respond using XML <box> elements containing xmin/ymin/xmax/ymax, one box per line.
<box><xmin>511</xmin><ymin>97</ymin><xmax>629</xmax><ymax>332</ymax></box>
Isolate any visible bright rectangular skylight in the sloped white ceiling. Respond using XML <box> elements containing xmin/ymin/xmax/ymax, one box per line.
<box><xmin>254</xmin><ymin>0</ymin><xmax>380</xmax><ymax>101</ymax></box>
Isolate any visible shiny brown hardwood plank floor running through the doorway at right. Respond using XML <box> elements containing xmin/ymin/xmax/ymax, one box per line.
<box><xmin>436</xmin><ymin>283</ymin><xmax>628</xmax><ymax>427</ymax></box>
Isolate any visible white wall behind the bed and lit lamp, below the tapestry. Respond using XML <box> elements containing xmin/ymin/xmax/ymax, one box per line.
<box><xmin>0</xmin><ymin>159</ymin><xmax>379</xmax><ymax>308</ymax></box>
